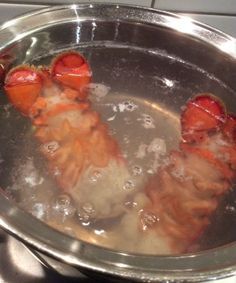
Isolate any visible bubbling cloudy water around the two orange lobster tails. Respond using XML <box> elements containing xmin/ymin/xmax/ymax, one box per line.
<box><xmin>0</xmin><ymin>46</ymin><xmax>235</xmax><ymax>253</ymax></box>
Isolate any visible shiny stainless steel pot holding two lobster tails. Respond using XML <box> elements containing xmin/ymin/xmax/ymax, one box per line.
<box><xmin>0</xmin><ymin>4</ymin><xmax>236</xmax><ymax>282</ymax></box>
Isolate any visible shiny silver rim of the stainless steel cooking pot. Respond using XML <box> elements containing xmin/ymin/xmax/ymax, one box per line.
<box><xmin>0</xmin><ymin>3</ymin><xmax>236</xmax><ymax>282</ymax></box>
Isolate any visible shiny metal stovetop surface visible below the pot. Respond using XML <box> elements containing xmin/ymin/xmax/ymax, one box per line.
<box><xmin>0</xmin><ymin>230</ymin><xmax>235</xmax><ymax>283</ymax></box>
